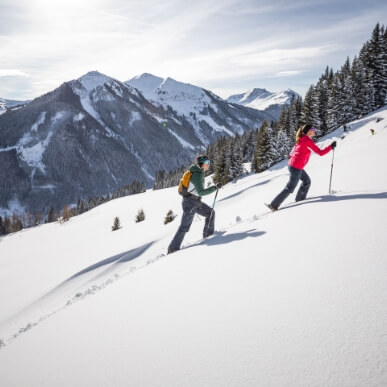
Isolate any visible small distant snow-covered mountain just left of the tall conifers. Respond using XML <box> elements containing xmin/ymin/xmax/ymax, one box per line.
<box><xmin>227</xmin><ymin>89</ymin><xmax>298</xmax><ymax>120</ymax></box>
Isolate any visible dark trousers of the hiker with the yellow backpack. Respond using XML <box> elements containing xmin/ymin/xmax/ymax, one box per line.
<box><xmin>168</xmin><ymin>196</ymin><xmax>215</xmax><ymax>251</ymax></box>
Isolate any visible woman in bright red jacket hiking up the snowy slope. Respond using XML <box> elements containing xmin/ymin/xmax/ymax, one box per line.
<box><xmin>267</xmin><ymin>124</ymin><xmax>336</xmax><ymax>211</ymax></box>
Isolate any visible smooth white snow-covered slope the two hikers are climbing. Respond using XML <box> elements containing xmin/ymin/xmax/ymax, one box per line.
<box><xmin>0</xmin><ymin>108</ymin><xmax>387</xmax><ymax>387</ymax></box>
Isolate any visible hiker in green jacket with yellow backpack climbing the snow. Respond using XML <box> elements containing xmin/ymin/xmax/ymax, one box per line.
<box><xmin>168</xmin><ymin>155</ymin><xmax>222</xmax><ymax>254</ymax></box>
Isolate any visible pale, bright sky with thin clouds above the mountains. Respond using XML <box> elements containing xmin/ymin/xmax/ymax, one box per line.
<box><xmin>0</xmin><ymin>0</ymin><xmax>387</xmax><ymax>100</ymax></box>
